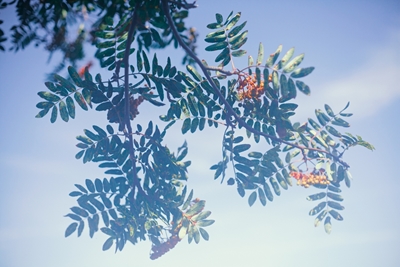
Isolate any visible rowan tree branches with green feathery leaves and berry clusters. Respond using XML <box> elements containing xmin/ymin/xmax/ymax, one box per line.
<box><xmin>0</xmin><ymin>0</ymin><xmax>374</xmax><ymax>259</ymax></box>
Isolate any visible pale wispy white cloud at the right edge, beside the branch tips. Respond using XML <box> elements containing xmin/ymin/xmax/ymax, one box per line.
<box><xmin>313</xmin><ymin>31</ymin><xmax>400</xmax><ymax>117</ymax></box>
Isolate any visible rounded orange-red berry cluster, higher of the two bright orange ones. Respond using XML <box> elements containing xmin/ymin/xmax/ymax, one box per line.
<box><xmin>237</xmin><ymin>74</ymin><xmax>264</xmax><ymax>100</ymax></box>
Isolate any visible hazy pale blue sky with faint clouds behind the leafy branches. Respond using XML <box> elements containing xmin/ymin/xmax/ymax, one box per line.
<box><xmin>0</xmin><ymin>0</ymin><xmax>400</xmax><ymax>267</ymax></box>
